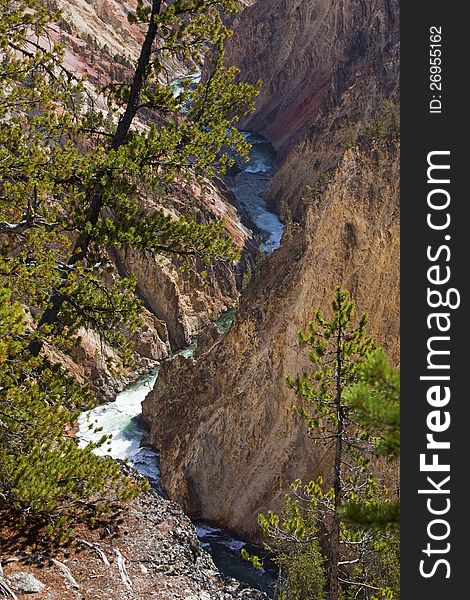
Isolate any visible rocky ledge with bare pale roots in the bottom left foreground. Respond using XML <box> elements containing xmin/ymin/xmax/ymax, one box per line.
<box><xmin>0</xmin><ymin>472</ymin><xmax>267</xmax><ymax>600</ymax></box>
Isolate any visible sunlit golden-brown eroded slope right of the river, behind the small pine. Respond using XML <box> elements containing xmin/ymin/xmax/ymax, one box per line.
<box><xmin>143</xmin><ymin>140</ymin><xmax>399</xmax><ymax>538</ymax></box>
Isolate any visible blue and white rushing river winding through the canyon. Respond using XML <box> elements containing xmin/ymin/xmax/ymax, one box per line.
<box><xmin>78</xmin><ymin>132</ymin><xmax>283</xmax><ymax>597</ymax></box>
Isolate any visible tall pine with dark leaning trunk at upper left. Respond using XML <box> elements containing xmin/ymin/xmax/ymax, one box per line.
<box><xmin>0</xmin><ymin>0</ymin><xmax>256</xmax><ymax>356</ymax></box>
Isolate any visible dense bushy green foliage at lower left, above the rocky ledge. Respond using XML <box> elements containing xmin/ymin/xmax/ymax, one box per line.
<box><xmin>0</xmin><ymin>288</ymin><xmax>145</xmax><ymax>535</ymax></box>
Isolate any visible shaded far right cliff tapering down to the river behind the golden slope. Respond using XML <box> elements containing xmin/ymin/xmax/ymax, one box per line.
<box><xmin>227</xmin><ymin>0</ymin><xmax>399</xmax><ymax>220</ymax></box>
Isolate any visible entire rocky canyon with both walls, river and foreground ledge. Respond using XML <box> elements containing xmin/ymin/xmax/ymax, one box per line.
<box><xmin>0</xmin><ymin>0</ymin><xmax>400</xmax><ymax>600</ymax></box>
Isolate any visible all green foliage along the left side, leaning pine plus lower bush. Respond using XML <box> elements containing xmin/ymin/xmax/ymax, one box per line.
<box><xmin>0</xmin><ymin>0</ymin><xmax>256</xmax><ymax>530</ymax></box>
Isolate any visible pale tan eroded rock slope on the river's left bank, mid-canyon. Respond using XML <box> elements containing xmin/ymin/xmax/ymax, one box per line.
<box><xmin>47</xmin><ymin>173</ymin><xmax>256</xmax><ymax>400</ymax></box>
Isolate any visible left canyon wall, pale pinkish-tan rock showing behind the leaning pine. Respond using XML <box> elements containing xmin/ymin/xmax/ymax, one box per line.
<box><xmin>48</xmin><ymin>0</ymin><xmax>257</xmax><ymax>400</ymax></box>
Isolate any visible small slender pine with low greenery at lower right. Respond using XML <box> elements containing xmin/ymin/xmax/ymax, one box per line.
<box><xmin>260</xmin><ymin>287</ymin><xmax>399</xmax><ymax>600</ymax></box>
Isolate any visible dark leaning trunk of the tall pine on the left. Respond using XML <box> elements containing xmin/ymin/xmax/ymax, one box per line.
<box><xmin>28</xmin><ymin>0</ymin><xmax>162</xmax><ymax>356</ymax></box>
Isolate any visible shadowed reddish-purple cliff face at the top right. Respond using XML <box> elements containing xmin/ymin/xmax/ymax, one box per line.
<box><xmin>226</xmin><ymin>0</ymin><xmax>399</xmax><ymax>149</ymax></box>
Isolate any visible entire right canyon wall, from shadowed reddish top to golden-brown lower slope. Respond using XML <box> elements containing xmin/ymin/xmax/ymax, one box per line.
<box><xmin>143</xmin><ymin>0</ymin><xmax>399</xmax><ymax>539</ymax></box>
